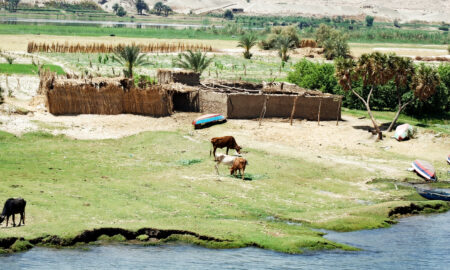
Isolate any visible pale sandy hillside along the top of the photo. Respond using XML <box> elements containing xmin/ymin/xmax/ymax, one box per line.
<box><xmin>22</xmin><ymin>0</ymin><xmax>450</xmax><ymax>22</ymax></box>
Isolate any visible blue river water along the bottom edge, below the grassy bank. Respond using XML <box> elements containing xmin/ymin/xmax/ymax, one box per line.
<box><xmin>0</xmin><ymin>212</ymin><xmax>450</xmax><ymax>270</ymax></box>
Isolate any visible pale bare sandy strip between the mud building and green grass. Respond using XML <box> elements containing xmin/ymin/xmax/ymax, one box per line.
<box><xmin>0</xmin><ymin>76</ymin><xmax>450</xmax><ymax>180</ymax></box>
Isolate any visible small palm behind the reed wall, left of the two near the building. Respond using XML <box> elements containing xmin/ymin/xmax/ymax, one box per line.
<box><xmin>113</xmin><ymin>45</ymin><xmax>151</xmax><ymax>78</ymax></box>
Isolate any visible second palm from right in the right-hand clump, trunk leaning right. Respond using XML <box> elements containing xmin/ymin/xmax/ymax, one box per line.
<box><xmin>387</xmin><ymin>55</ymin><xmax>414</xmax><ymax>132</ymax></box>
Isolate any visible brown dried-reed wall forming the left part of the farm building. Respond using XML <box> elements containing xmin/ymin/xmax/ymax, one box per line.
<box><xmin>41</xmin><ymin>78</ymin><xmax>172</xmax><ymax>116</ymax></box>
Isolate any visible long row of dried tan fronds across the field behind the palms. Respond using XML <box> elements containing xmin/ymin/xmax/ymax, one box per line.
<box><xmin>27</xmin><ymin>41</ymin><xmax>214</xmax><ymax>53</ymax></box>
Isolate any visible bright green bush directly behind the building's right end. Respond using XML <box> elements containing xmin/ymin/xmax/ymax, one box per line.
<box><xmin>288</xmin><ymin>59</ymin><xmax>338</xmax><ymax>93</ymax></box>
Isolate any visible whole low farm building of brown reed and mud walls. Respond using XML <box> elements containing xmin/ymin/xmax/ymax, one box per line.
<box><xmin>40</xmin><ymin>70</ymin><xmax>342</xmax><ymax>120</ymax></box>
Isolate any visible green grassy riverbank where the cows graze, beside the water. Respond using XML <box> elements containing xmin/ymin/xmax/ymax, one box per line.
<box><xmin>0</xmin><ymin>130</ymin><xmax>448</xmax><ymax>253</ymax></box>
